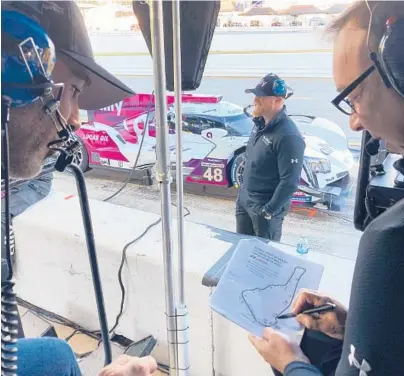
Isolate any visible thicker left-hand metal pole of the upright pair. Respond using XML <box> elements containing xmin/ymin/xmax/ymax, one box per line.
<box><xmin>149</xmin><ymin>0</ymin><xmax>178</xmax><ymax>375</ymax></box>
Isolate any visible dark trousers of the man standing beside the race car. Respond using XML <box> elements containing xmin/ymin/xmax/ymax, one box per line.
<box><xmin>236</xmin><ymin>200</ymin><xmax>286</xmax><ymax>242</ymax></box>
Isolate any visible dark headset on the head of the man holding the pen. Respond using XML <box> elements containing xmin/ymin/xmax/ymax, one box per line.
<box><xmin>370</xmin><ymin>16</ymin><xmax>404</xmax><ymax>98</ymax></box>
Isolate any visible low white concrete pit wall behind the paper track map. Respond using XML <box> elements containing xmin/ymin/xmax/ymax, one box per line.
<box><xmin>14</xmin><ymin>193</ymin><xmax>353</xmax><ymax>376</ymax></box>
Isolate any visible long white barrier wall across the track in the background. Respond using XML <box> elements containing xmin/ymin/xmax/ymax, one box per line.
<box><xmin>91</xmin><ymin>29</ymin><xmax>332</xmax><ymax>78</ymax></box>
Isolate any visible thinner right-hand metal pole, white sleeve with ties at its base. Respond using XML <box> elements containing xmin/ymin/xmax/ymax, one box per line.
<box><xmin>172</xmin><ymin>0</ymin><xmax>189</xmax><ymax>376</ymax></box>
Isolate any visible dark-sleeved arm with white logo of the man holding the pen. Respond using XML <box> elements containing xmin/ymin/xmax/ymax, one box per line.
<box><xmin>336</xmin><ymin>217</ymin><xmax>404</xmax><ymax>376</ymax></box>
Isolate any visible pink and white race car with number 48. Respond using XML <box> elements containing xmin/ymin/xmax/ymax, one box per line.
<box><xmin>75</xmin><ymin>94</ymin><xmax>354</xmax><ymax>210</ymax></box>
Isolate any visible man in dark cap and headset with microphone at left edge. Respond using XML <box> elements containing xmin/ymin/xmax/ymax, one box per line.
<box><xmin>1</xmin><ymin>1</ymin><xmax>157</xmax><ymax>376</ymax></box>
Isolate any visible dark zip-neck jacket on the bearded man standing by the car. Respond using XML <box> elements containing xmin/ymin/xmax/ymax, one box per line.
<box><xmin>238</xmin><ymin>107</ymin><xmax>306</xmax><ymax>215</ymax></box>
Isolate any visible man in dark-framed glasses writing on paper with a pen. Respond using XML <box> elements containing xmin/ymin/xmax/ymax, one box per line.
<box><xmin>250</xmin><ymin>1</ymin><xmax>404</xmax><ymax>376</ymax></box>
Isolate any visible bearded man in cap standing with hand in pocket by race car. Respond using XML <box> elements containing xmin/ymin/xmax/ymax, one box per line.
<box><xmin>236</xmin><ymin>74</ymin><xmax>306</xmax><ymax>242</ymax></box>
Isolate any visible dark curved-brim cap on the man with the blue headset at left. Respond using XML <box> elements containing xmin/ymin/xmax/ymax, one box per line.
<box><xmin>1</xmin><ymin>1</ymin><xmax>135</xmax><ymax>110</ymax></box>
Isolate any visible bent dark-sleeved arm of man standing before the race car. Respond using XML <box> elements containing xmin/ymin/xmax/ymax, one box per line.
<box><xmin>264</xmin><ymin>135</ymin><xmax>306</xmax><ymax>215</ymax></box>
